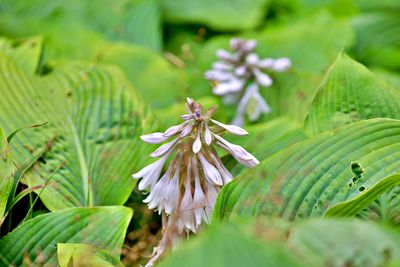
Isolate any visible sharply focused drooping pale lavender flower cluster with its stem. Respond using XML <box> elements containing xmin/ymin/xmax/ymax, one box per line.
<box><xmin>133</xmin><ymin>98</ymin><xmax>259</xmax><ymax>266</ymax></box>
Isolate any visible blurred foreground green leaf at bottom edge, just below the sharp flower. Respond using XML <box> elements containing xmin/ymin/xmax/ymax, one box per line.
<box><xmin>159</xmin><ymin>225</ymin><xmax>307</xmax><ymax>267</ymax></box>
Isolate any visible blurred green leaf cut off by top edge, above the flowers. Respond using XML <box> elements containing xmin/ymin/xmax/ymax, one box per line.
<box><xmin>160</xmin><ymin>0</ymin><xmax>269</xmax><ymax>31</ymax></box>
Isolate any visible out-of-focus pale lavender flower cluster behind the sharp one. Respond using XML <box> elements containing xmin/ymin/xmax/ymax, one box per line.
<box><xmin>205</xmin><ymin>38</ymin><xmax>291</xmax><ymax>126</ymax></box>
